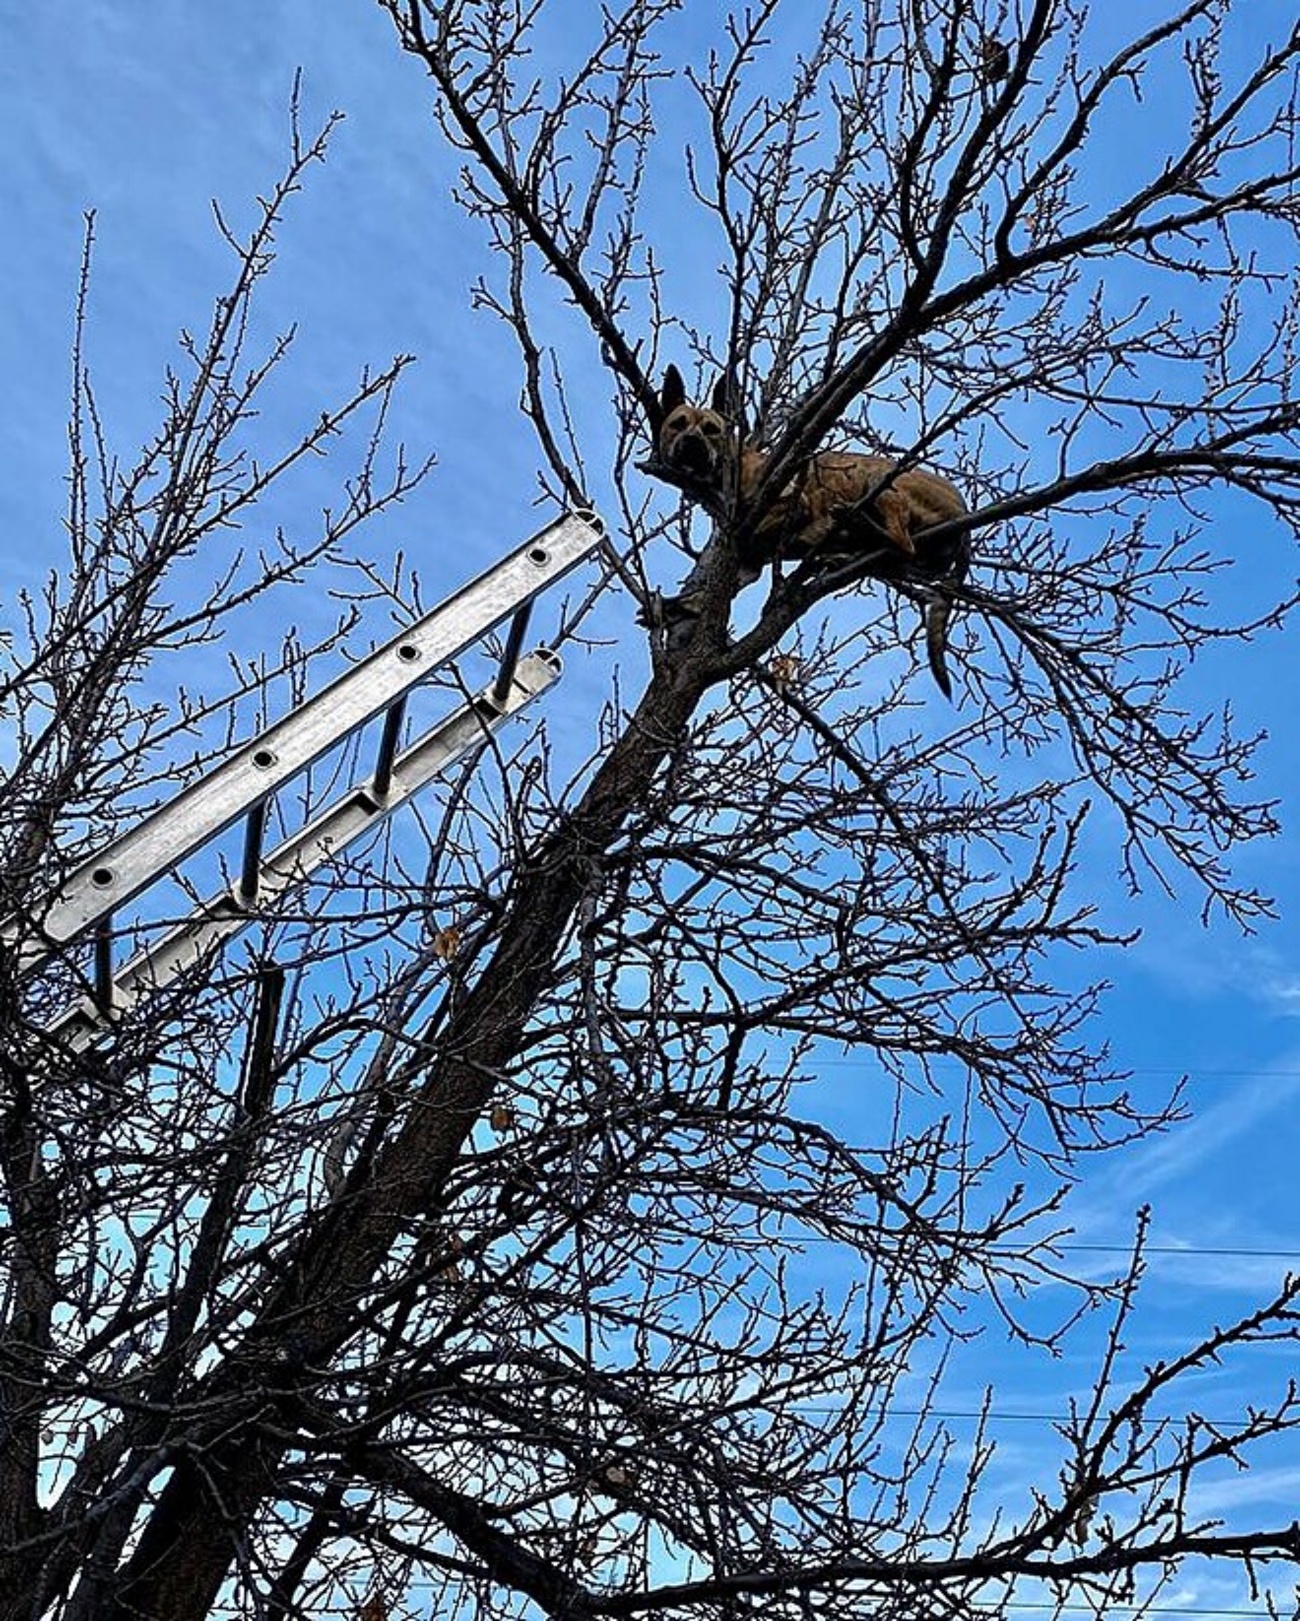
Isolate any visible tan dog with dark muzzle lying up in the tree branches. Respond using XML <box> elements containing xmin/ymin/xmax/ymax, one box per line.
<box><xmin>658</xmin><ymin>366</ymin><xmax>969</xmax><ymax>699</ymax></box>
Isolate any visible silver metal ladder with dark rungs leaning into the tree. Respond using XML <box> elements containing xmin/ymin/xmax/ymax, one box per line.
<box><xmin>0</xmin><ymin>512</ymin><xmax>605</xmax><ymax>1049</ymax></box>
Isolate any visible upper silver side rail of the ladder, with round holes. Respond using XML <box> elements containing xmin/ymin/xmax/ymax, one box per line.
<box><xmin>16</xmin><ymin>514</ymin><xmax>603</xmax><ymax>971</ymax></box>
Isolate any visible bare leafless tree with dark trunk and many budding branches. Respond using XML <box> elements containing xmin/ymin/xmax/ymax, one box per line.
<box><xmin>0</xmin><ymin>0</ymin><xmax>1300</xmax><ymax>1621</ymax></box>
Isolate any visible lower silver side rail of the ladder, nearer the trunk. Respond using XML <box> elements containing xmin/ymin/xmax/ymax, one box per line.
<box><xmin>47</xmin><ymin>648</ymin><xmax>562</xmax><ymax>1052</ymax></box>
